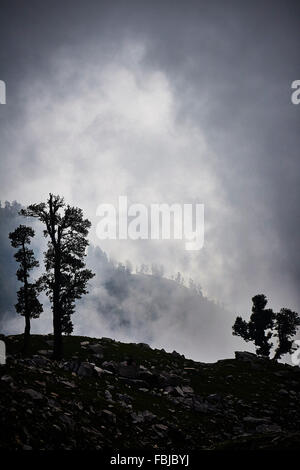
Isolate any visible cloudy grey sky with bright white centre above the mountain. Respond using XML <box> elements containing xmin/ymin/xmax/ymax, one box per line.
<box><xmin>0</xmin><ymin>0</ymin><xmax>300</xmax><ymax>320</ymax></box>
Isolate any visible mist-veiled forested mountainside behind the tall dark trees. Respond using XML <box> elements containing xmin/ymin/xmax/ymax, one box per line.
<box><xmin>0</xmin><ymin>202</ymin><xmax>239</xmax><ymax>361</ymax></box>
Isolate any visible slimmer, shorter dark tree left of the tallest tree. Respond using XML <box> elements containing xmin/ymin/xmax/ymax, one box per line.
<box><xmin>9</xmin><ymin>225</ymin><xmax>43</xmax><ymax>353</ymax></box>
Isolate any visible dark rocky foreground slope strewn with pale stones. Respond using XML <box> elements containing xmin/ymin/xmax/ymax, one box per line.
<box><xmin>0</xmin><ymin>336</ymin><xmax>300</xmax><ymax>452</ymax></box>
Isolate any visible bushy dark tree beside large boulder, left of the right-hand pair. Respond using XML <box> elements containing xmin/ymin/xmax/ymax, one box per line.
<box><xmin>232</xmin><ymin>294</ymin><xmax>275</xmax><ymax>357</ymax></box>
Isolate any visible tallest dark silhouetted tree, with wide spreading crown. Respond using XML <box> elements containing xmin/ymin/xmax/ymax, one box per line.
<box><xmin>20</xmin><ymin>194</ymin><xmax>94</xmax><ymax>359</ymax></box>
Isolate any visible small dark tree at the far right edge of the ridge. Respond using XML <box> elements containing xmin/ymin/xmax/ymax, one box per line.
<box><xmin>274</xmin><ymin>308</ymin><xmax>300</xmax><ymax>359</ymax></box>
